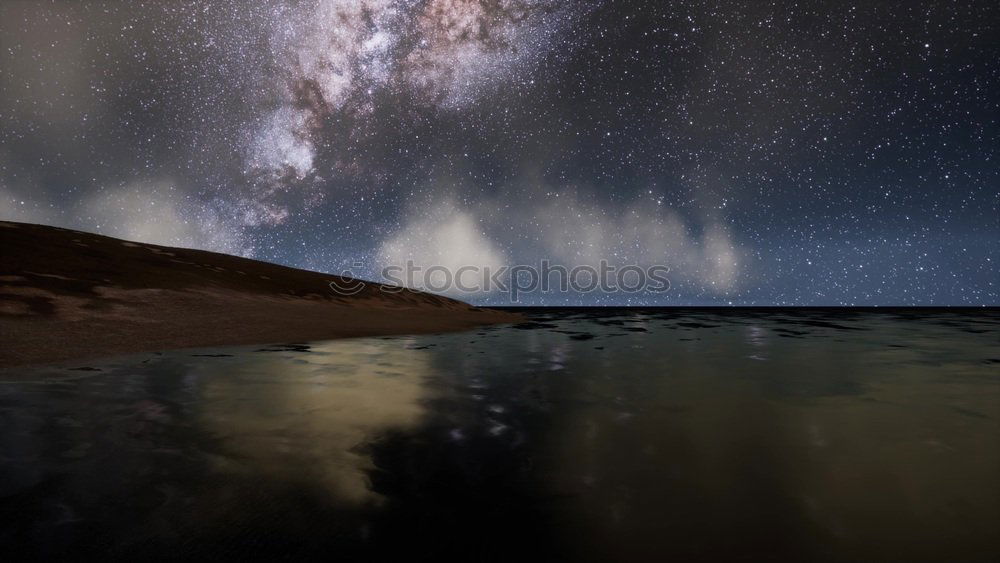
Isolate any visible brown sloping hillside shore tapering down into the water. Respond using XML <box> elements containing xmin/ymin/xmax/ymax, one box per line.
<box><xmin>0</xmin><ymin>221</ymin><xmax>520</xmax><ymax>368</ymax></box>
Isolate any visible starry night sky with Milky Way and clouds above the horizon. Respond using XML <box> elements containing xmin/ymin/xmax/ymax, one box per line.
<box><xmin>0</xmin><ymin>0</ymin><xmax>1000</xmax><ymax>305</ymax></box>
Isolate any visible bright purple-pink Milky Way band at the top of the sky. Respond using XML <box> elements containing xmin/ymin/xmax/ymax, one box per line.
<box><xmin>248</xmin><ymin>0</ymin><xmax>586</xmax><ymax>196</ymax></box>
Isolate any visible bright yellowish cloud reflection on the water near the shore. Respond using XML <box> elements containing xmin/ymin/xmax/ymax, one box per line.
<box><xmin>192</xmin><ymin>338</ymin><xmax>430</xmax><ymax>504</ymax></box>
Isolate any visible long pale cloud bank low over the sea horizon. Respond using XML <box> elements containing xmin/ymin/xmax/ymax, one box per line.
<box><xmin>376</xmin><ymin>187</ymin><xmax>744</xmax><ymax>299</ymax></box>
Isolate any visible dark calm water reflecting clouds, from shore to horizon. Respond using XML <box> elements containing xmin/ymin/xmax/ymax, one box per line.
<box><xmin>0</xmin><ymin>309</ymin><xmax>1000</xmax><ymax>561</ymax></box>
